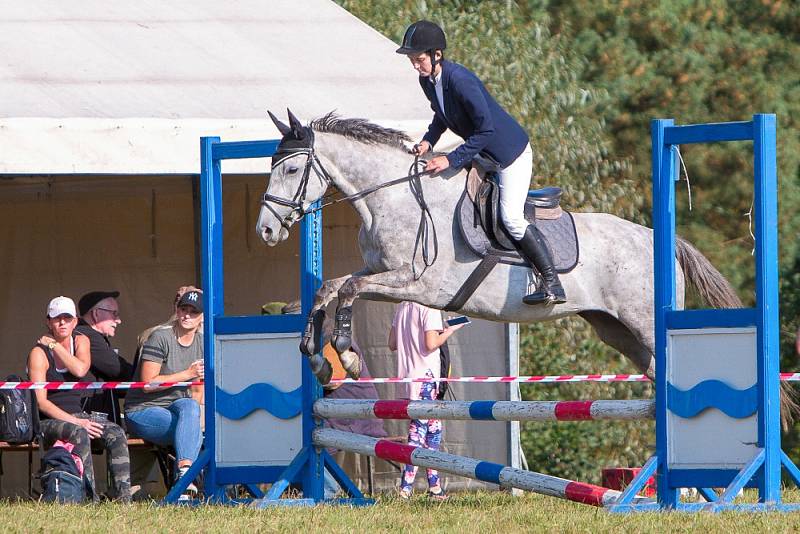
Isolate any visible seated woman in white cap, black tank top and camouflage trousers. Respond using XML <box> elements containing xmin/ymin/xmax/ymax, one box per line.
<box><xmin>28</xmin><ymin>297</ymin><xmax>131</xmax><ymax>502</ymax></box>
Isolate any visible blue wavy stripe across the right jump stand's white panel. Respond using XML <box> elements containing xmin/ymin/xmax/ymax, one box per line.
<box><xmin>667</xmin><ymin>380</ymin><xmax>758</xmax><ymax>419</ymax></box>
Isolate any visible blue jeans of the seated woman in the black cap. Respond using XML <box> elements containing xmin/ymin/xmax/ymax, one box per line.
<box><xmin>125</xmin><ymin>398</ymin><xmax>203</xmax><ymax>463</ymax></box>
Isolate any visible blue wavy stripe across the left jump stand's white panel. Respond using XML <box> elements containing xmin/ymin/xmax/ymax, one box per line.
<box><xmin>216</xmin><ymin>383</ymin><xmax>303</xmax><ymax>420</ymax></box>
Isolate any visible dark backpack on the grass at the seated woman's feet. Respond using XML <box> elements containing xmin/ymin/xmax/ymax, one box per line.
<box><xmin>39</xmin><ymin>446</ymin><xmax>94</xmax><ymax>504</ymax></box>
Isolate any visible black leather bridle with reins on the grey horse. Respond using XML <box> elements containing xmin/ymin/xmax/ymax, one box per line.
<box><xmin>261</xmin><ymin>127</ymin><xmax>439</xmax><ymax>279</ymax></box>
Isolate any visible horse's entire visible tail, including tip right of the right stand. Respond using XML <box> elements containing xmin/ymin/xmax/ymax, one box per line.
<box><xmin>675</xmin><ymin>237</ymin><xmax>800</xmax><ymax>430</ymax></box>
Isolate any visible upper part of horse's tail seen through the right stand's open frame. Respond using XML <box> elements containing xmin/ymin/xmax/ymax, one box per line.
<box><xmin>675</xmin><ymin>237</ymin><xmax>742</xmax><ymax>308</ymax></box>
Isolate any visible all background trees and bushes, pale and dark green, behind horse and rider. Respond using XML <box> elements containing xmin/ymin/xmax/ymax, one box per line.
<box><xmin>338</xmin><ymin>0</ymin><xmax>800</xmax><ymax>482</ymax></box>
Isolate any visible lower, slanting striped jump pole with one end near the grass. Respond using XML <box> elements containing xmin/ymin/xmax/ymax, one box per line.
<box><xmin>314</xmin><ymin>428</ymin><xmax>653</xmax><ymax>506</ymax></box>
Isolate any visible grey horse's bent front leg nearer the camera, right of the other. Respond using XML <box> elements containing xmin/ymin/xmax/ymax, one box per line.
<box><xmin>331</xmin><ymin>265</ymin><xmax>435</xmax><ymax>360</ymax></box>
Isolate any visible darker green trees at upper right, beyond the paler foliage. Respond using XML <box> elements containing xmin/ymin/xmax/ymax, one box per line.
<box><xmin>549</xmin><ymin>0</ymin><xmax>800</xmax><ymax>304</ymax></box>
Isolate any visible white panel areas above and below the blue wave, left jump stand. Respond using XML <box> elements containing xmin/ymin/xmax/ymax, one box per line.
<box><xmin>214</xmin><ymin>333</ymin><xmax>303</xmax><ymax>467</ymax></box>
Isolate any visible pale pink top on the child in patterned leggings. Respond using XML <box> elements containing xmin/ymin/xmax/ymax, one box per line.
<box><xmin>392</xmin><ymin>302</ymin><xmax>444</xmax><ymax>400</ymax></box>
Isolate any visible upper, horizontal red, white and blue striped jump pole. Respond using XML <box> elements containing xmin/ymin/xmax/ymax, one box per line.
<box><xmin>314</xmin><ymin>399</ymin><xmax>655</xmax><ymax>421</ymax></box>
